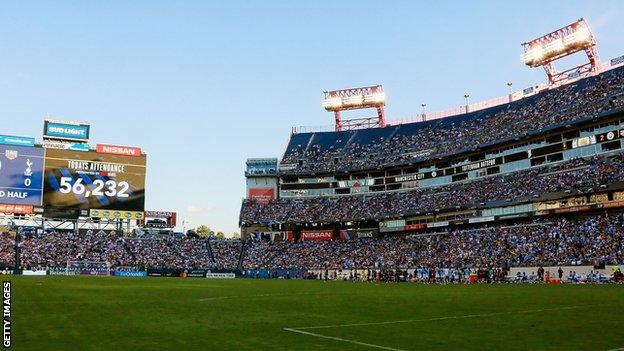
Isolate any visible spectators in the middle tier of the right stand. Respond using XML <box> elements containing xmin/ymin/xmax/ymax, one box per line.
<box><xmin>240</xmin><ymin>154</ymin><xmax>624</xmax><ymax>225</ymax></box>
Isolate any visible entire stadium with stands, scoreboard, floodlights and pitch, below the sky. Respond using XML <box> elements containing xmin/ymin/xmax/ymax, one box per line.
<box><xmin>0</xmin><ymin>6</ymin><xmax>624</xmax><ymax>351</ymax></box>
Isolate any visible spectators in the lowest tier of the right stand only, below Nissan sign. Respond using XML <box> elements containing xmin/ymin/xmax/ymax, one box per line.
<box><xmin>243</xmin><ymin>214</ymin><xmax>624</xmax><ymax>270</ymax></box>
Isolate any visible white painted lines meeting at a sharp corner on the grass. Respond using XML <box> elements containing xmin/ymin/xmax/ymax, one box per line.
<box><xmin>283</xmin><ymin>304</ymin><xmax>604</xmax><ymax>351</ymax></box>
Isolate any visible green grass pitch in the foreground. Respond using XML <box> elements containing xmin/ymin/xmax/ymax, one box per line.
<box><xmin>10</xmin><ymin>276</ymin><xmax>624</xmax><ymax>351</ymax></box>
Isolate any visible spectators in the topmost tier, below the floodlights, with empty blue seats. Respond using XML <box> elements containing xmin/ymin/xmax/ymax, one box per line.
<box><xmin>281</xmin><ymin>68</ymin><xmax>624</xmax><ymax>173</ymax></box>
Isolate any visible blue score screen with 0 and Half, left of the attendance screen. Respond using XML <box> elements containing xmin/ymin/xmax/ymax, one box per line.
<box><xmin>0</xmin><ymin>145</ymin><xmax>44</xmax><ymax>206</ymax></box>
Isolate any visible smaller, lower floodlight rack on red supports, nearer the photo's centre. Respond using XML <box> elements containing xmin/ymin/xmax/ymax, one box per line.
<box><xmin>322</xmin><ymin>85</ymin><xmax>386</xmax><ymax>131</ymax></box>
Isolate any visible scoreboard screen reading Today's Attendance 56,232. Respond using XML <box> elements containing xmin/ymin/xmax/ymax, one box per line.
<box><xmin>43</xmin><ymin>149</ymin><xmax>147</xmax><ymax>211</ymax></box>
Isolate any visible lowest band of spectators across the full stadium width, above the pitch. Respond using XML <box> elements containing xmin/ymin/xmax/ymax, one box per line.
<box><xmin>0</xmin><ymin>214</ymin><xmax>624</xmax><ymax>270</ymax></box>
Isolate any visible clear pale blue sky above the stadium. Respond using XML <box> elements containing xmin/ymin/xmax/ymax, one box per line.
<box><xmin>0</xmin><ymin>0</ymin><xmax>624</xmax><ymax>234</ymax></box>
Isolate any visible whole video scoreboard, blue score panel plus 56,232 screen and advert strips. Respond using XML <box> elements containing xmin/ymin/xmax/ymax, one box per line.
<box><xmin>0</xmin><ymin>137</ymin><xmax>147</xmax><ymax>219</ymax></box>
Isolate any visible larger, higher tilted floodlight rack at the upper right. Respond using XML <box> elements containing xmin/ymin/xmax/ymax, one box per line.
<box><xmin>520</xmin><ymin>18</ymin><xmax>599</xmax><ymax>86</ymax></box>
